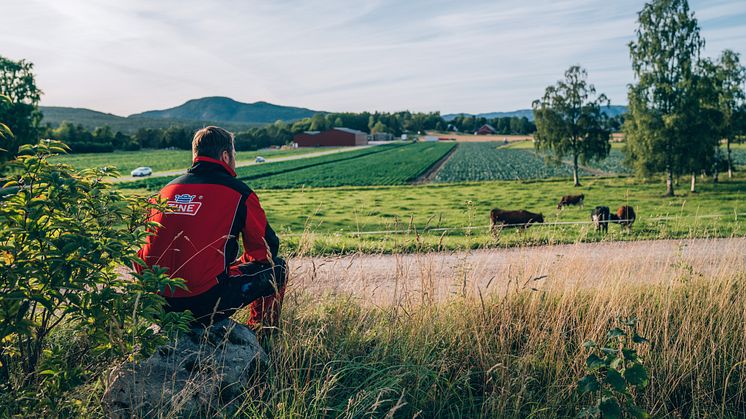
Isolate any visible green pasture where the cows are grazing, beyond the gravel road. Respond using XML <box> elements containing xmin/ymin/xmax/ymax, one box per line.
<box><xmin>258</xmin><ymin>174</ymin><xmax>746</xmax><ymax>254</ymax></box>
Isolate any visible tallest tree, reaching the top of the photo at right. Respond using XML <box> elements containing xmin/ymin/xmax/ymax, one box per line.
<box><xmin>624</xmin><ymin>0</ymin><xmax>704</xmax><ymax>196</ymax></box>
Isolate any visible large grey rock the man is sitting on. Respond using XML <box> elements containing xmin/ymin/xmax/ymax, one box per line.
<box><xmin>103</xmin><ymin>319</ymin><xmax>267</xmax><ymax>417</ymax></box>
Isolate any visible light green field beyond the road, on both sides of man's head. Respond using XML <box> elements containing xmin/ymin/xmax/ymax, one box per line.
<box><xmin>51</xmin><ymin>148</ymin><xmax>322</xmax><ymax>175</ymax></box>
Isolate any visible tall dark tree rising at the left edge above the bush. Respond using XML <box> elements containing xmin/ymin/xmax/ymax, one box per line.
<box><xmin>0</xmin><ymin>56</ymin><xmax>42</xmax><ymax>160</ymax></box>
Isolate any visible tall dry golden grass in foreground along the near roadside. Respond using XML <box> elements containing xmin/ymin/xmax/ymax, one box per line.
<box><xmin>218</xmin><ymin>241</ymin><xmax>746</xmax><ymax>417</ymax></box>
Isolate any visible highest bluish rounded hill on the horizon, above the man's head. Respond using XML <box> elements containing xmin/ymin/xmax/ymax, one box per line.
<box><xmin>129</xmin><ymin>96</ymin><xmax>318</xmax><ymax>124</ymax></box>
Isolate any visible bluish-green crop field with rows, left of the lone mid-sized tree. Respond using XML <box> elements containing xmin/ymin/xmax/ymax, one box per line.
<box><xmin>434</xmin><ymin>142</ymin><xmax>589</xmax><ymax>182</ymax></box>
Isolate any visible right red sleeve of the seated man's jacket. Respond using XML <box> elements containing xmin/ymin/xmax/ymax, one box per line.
<box><xmin>241</xmin><ymin>192</ymin><xmax>280</xmax><ymax>263</ymax></box>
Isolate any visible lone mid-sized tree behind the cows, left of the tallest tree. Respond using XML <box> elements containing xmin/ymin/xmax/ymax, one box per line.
<box><xmin>532</xmin><ymin>65</ymin><xmax>611</xmax><ymax>186</ymax></box>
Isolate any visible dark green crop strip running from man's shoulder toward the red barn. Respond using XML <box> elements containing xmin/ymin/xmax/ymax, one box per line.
<box><xmin>249</xmin><ymin>143</ymin><xmax>455</xmax><ymax>189</ymax></box>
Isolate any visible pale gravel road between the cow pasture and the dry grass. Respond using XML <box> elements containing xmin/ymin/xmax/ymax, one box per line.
<box><xmin>290</xmin><ymin>238</ymin><xmax>746</xmax><ymax>305</ymax></box>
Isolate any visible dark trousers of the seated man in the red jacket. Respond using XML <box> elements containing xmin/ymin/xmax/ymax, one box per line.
<box><xmin>166</xmin><ymin>258</ymin><xmax>287</xmax><ymax>326</ymax></box>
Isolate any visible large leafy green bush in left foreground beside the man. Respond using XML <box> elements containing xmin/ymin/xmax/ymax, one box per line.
<box><xmin>0</xmin><ymin>140</ymin><xmax>190</xmax><ymax>416</ymax></box>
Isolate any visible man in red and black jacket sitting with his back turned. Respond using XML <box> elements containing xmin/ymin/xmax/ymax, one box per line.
<box><xmin>138</xmin><ymin>126</ymin><xmax>287</xmax><ymax>329</ymax></box>
